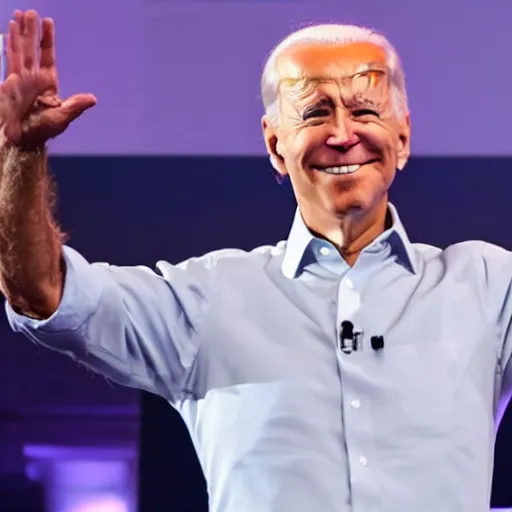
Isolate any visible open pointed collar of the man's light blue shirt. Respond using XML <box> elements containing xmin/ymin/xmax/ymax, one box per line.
<box><xmin>281</xmin><ymin>203</ymin><xmax>417</xmax><ymax>279</ymax></box>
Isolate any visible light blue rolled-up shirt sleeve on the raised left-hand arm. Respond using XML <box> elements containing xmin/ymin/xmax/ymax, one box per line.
<box><xmin>5</xmin><ymin>246</ymin><xmax>212</xmax><ymax>402</ymax></box>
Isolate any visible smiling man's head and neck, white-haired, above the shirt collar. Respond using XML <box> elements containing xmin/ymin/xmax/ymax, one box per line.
<box><xmin>263</xmin><ymin>37</ymin><xmax>410</xmax><ymax>263</ymax></box>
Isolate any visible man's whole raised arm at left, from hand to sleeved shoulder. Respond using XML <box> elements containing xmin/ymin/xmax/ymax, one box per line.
<box><xmin>0</xmin><ymin>11</ymin><xmax>214</xmax><ymax>401</ymax></box>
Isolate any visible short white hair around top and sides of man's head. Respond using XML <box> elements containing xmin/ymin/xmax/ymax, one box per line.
<box><xmin>261</xmin><ymin>24</ymin><xmax>409</xmax><ymax>123</ymax></box>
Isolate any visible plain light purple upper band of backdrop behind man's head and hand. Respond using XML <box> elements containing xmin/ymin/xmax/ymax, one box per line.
<box><xmin>0</xmin><ymin>0</ymin><xmax>512</xmax><ymax>156</ymax></box>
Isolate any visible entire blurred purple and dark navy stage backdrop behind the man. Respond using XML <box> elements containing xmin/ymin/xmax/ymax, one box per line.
<box><xmin>0</xmin><ymin>0</ymin><xmax>512</xmax><ymax>512</ymax></box>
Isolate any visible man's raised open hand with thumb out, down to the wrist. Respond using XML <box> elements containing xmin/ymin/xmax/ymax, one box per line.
<box><xmin>0</xmin><ymin>10</ymin><xmax>96</xmax><ymax>149</ymax></box>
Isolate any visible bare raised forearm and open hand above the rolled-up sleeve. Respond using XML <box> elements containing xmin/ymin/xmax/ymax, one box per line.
<box><xmin>0</xmin><ymin>11</ymin><xmax>96</xmax><ymax>319</ymax></box>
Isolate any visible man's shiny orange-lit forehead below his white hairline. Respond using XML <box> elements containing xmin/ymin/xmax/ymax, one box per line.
<box><xmin>276</xmin><ymin>42</ymin><xmax>387</xmax><ymax>80</ymax></box>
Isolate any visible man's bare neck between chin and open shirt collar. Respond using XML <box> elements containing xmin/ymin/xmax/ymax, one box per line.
<box><xmin>303</xmin><ymin>197</ymin><xmax>388</xmax><ymax>266</ymax></box>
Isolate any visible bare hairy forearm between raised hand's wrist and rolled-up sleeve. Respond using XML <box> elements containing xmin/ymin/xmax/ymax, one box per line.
<box><xmin>0</xmin><ymin>147</ymin><xmax>63</xmax><ymax>318</ymax></box>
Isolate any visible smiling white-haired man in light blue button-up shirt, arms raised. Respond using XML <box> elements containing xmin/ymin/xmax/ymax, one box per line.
<box><xmin>0</xmin><ymin>8</ymin><xmax>512</xmax><ymax>512</ymax></box>
